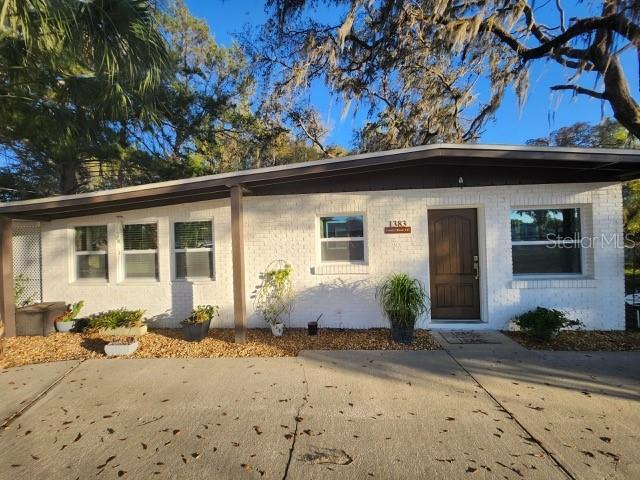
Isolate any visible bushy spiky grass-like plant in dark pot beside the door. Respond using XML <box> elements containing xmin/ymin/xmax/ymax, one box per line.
<box><xmin>376</xmin><ymin>273</ymin><xmax>430</xmax><ymax>344</ymax></box>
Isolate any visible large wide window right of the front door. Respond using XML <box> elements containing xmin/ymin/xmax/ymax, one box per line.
<box><xmin>511</xmin><ymin>208</ymin><xmax>582</xmax><ymax>275</ymax></box>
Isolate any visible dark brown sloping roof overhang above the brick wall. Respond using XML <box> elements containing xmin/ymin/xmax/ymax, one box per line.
<box><xmin>0</xmin><ymin>144</ymin><xmax>640</xmax><ymax>221</ymax></box>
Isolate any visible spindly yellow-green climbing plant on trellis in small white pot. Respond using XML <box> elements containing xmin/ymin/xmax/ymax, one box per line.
<box><xmin>255</xmin><ymin>260</ymin><xmax>293</xmax><ymax>337</ymax></box>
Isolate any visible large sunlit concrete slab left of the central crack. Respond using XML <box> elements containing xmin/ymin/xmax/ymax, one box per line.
<box><xmin>0</xmin><ymin>358</ymin><xmax>304</xmax><ymax>479</ymax></box>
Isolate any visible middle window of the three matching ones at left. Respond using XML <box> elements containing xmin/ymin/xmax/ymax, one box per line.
<box><xmin>122</xmin><ymin>223</ymin><xmax>158</xmax><ymax>280</ymax></box>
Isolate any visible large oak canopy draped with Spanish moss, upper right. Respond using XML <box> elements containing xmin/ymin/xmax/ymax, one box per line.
<box><xmin>254</xmin><ymin>0</ymin><xmax>640</xmax><ymax>150</ymax></box>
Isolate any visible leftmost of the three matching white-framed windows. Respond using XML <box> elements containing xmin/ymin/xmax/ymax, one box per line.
<box><xmin>75</xmin><ymin>225</ymin><xmax>109</xmax><ymax>280</ymax></box>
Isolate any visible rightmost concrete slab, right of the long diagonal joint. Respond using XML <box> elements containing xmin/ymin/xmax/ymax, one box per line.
<box><xmin>443</xmin><ymin>334</ymin><xmax>640</xmax><ymax>479</ymax></box>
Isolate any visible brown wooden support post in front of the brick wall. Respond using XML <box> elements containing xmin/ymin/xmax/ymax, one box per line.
<box><xmin>231</xmin><ymin>185</ymin><xmax>247</xmax><ymax>343</ymax></box>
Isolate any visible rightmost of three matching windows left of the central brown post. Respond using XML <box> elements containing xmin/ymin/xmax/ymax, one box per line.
<box><xmin>173</xmin><ymin>221</ymin><xmax>213</xmax><ymax>278</ymax></box>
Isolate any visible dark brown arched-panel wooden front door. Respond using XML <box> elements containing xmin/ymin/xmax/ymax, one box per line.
<box><xmin>429</xmin><ymin>208</ymin><xmax>480</xmax><ymax>320</ymax></box>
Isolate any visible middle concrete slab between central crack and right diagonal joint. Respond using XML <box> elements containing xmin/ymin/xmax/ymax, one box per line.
<box><xmin>289</xmin><ymin>351</ymin><xmax>564</xmax><ymax>479</ymax></box>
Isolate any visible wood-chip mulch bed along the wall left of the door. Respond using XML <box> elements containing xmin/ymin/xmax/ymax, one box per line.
<box><xmin>0</xmin><ymin>328</ymin><xmax>440</xmax><ymax>368</ymax></box>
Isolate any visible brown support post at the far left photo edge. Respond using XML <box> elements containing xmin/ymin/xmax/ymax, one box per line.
<box><xmin>0</xmin><ymin>218</ymin><xmax>16</xmax><ymax>338</ymax></box>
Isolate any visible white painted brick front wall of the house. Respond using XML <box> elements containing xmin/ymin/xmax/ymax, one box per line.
<box><xmin>42</xmin><ymin>184</ymin><xmax>624</xmax><ymax>329</ymax></box>
